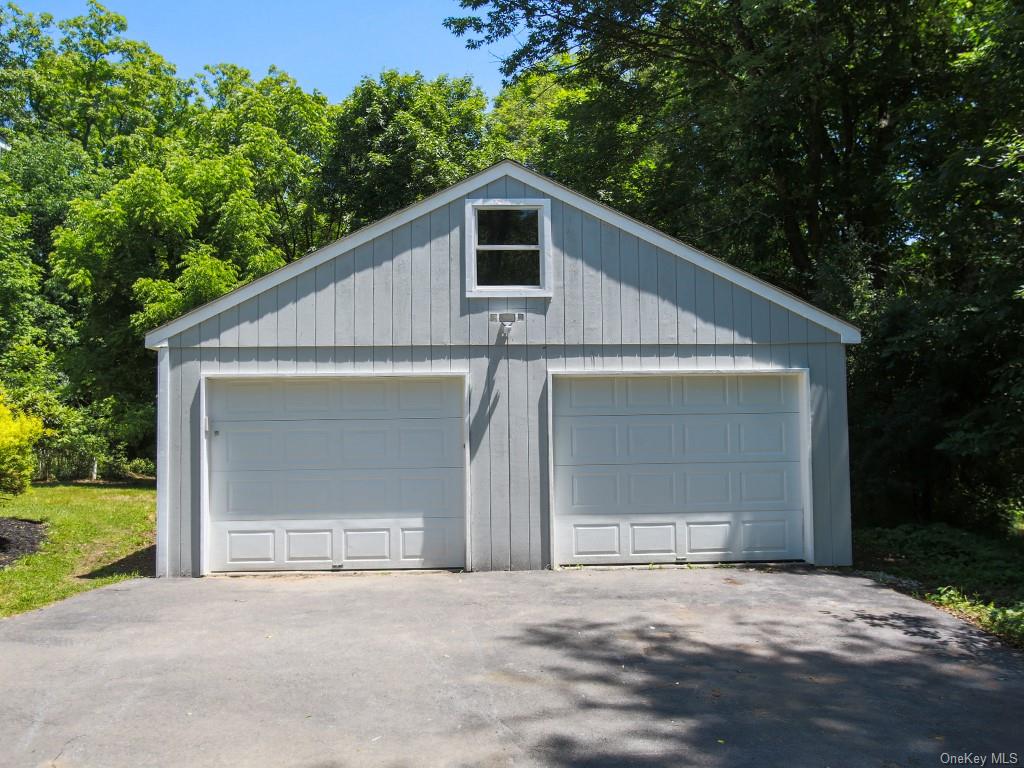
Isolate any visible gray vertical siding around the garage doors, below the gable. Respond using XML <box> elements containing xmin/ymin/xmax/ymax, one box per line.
<box><xmin>168</xmin><ymin>342</ymin><xmax>851</xmax><ymax>574</ymax></box>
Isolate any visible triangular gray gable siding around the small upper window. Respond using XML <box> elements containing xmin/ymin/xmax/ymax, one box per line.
<box><xmin>170</xmin><ymin>179</ymin><xmax>839</xmax><ymax>354</ymax></box>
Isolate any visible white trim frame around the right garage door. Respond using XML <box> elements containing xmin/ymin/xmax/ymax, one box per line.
<box><xmin>548</xmin><ymin>368</ymin><xmax>814</xmax><ymax>570</ymax></box>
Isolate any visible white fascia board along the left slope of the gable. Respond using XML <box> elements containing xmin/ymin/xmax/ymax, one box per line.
<box><xmin>145</xmin><ymin>160</ymin><xmax>519</xmax><ymax>349</ymax></box>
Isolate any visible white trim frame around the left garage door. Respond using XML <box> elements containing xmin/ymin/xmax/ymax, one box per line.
<box><xmin>193</xmin><ymin>371</ymin><xmax>473</xmax><ymax>575</ymax></box>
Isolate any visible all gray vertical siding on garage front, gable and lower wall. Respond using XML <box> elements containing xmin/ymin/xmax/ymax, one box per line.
<box><xmin>165</xmin><ymin>171</ymin><xmax>852</xmax><ymax>575</ymax></box>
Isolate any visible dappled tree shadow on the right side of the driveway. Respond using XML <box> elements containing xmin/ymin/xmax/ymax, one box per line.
<box><xmin>489</xmin><ymin>593</ymin><xmax>1024</xmax><ymax>768</ymax></box>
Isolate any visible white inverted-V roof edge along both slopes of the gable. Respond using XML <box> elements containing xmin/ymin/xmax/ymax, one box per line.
<box><xmin>145</xmin><ymin>160</ymin><xmax>860</xmax><ymax>349</ymax></box>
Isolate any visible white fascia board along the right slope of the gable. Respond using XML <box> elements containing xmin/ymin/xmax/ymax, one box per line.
<box><xmin>503</xmin><ymin>163</ymin><xmax>860</xmax><ymax>344</ymax></box>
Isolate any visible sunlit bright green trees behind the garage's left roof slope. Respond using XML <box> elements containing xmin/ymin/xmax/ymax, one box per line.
<box><xmin>0</xmin><ymin>1</ymin><xmax>495</xmax><ymax>477</ymax></box>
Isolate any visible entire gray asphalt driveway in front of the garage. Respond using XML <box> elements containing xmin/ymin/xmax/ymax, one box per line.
<box><xmin>0</xmin><ymin>568</ymin><xmax>1024</xmax><ymax>768</ymax></box>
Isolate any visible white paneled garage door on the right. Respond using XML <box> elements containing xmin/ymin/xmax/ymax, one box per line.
<box><xmin>554</xmin><ymin>374</ymin><xmax>806</xmax><ymax>563</ymax></box>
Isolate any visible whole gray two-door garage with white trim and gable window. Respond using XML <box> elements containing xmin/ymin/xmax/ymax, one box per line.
<box><xmin>146</xmin><ymin>162</ymin><xmax>859</xmax><ymax>575</ymax></box>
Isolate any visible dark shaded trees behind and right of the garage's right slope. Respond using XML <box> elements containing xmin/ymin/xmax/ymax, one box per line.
<box><xmin>456</xmin><ymin>0</ymin><xmax>1024</xmax><ymax>528</ymax></box>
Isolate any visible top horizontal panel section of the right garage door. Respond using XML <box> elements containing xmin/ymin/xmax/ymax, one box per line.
<box><xmin>554</xmin><ymin>374</ymin><xmax>800</xmax><ymax>416</ymax></box>
